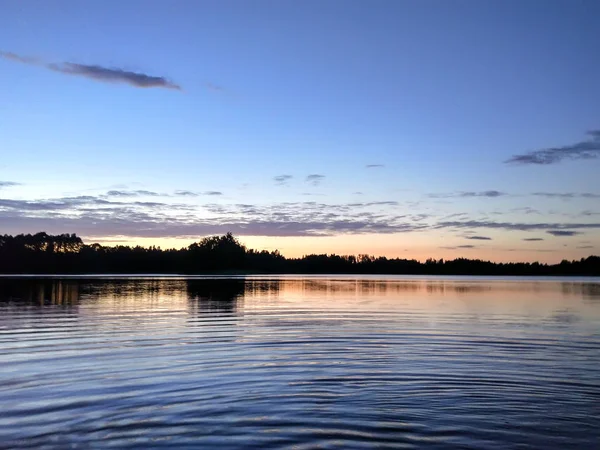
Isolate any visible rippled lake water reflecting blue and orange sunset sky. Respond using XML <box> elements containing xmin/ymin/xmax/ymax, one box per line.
<box><xmin>0</xmin><ymin>276</ymin><xmax>600</xmax><ymax>449</ymax></box>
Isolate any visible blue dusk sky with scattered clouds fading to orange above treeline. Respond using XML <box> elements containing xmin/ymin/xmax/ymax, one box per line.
<box><xmin>0</xmin><ymin>0</ymin><xmax>600</xmax><ymax>262</ymax></box>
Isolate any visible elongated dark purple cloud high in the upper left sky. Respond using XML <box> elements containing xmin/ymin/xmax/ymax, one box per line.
<box><xmin>0</xmin><ymin>52</ymin><xmax>181</xmax><ymax>90</ymax></box>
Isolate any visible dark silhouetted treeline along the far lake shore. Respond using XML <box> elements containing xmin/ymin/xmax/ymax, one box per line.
<box><xmin>0</xmin><ymin>232</ymin><xmax>600</xmax><ymax>276</ymax></box>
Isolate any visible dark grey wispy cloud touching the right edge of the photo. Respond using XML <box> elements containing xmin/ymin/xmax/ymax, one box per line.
<box><xmin>505</xmin><ymin>130</ymin><xmax>600</xmax><ymax>165</ymax></box>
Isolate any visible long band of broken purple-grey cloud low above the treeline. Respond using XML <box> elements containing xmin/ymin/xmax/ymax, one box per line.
<box><xmin>0</xmin><ymin>196</ymin><xmax>429</xmax><ymax>238</ymax></box>
